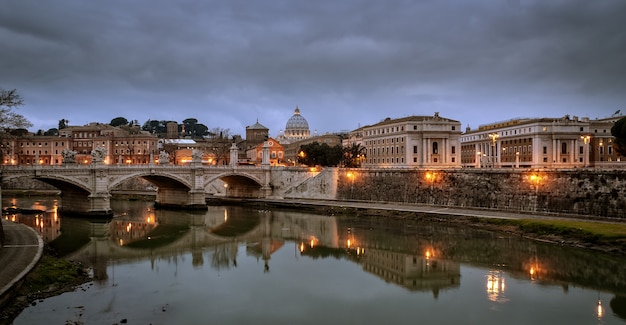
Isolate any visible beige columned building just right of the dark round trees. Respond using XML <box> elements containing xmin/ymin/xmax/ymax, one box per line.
<box><xmin>355</xmin><ymin>113</ymin><xmax>461</xmax><ymax>168</ymax></box>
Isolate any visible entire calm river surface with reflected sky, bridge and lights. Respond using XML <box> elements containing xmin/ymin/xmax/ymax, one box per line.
<box><xmin>3</xmin><ymin>198</ymin><xmax>626</xmax><ymax>324</ymax></box>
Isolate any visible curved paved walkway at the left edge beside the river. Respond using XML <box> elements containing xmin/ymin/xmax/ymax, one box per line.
<box><xmin>0</xmin><ymin>218</ymin><xmax>43</xmax><ymax>306</ymax></box>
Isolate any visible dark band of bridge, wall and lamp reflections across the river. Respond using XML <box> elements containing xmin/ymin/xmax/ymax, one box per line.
<box><xmin>4</xmin><ymin>196</ymin><xmax>626</xmax><ymax>322</ymax></box>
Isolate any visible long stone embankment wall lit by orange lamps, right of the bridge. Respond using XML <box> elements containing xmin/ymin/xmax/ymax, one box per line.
<box><xmin>336</xmin><ymin>169</ymin><xmax>626</xmax><ymax>218</ymax></box>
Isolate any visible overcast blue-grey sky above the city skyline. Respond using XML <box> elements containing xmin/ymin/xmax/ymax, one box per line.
<box><xmin>0</xmin><ymin>0</ymin><xmax>626</xmax><ymax>136</ymax></box>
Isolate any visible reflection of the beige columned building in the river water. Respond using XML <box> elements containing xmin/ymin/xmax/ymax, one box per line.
<box><xmin>363</xmin><ymin>248</ymin><xmax>461</xmax><ymax>296</ymax></box>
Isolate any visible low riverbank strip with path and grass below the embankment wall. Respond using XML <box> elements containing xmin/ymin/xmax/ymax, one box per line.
<box><xmin>212</xmin><ymin>199</ymin><xmax>626</xmax><ymax>256</ymax></box>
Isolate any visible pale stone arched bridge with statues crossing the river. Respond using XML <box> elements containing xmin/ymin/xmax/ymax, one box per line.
<box><xmin>0</xmin><ymin>162</ymin><xmax>314</xmax><ymax>216</ymax></box>
